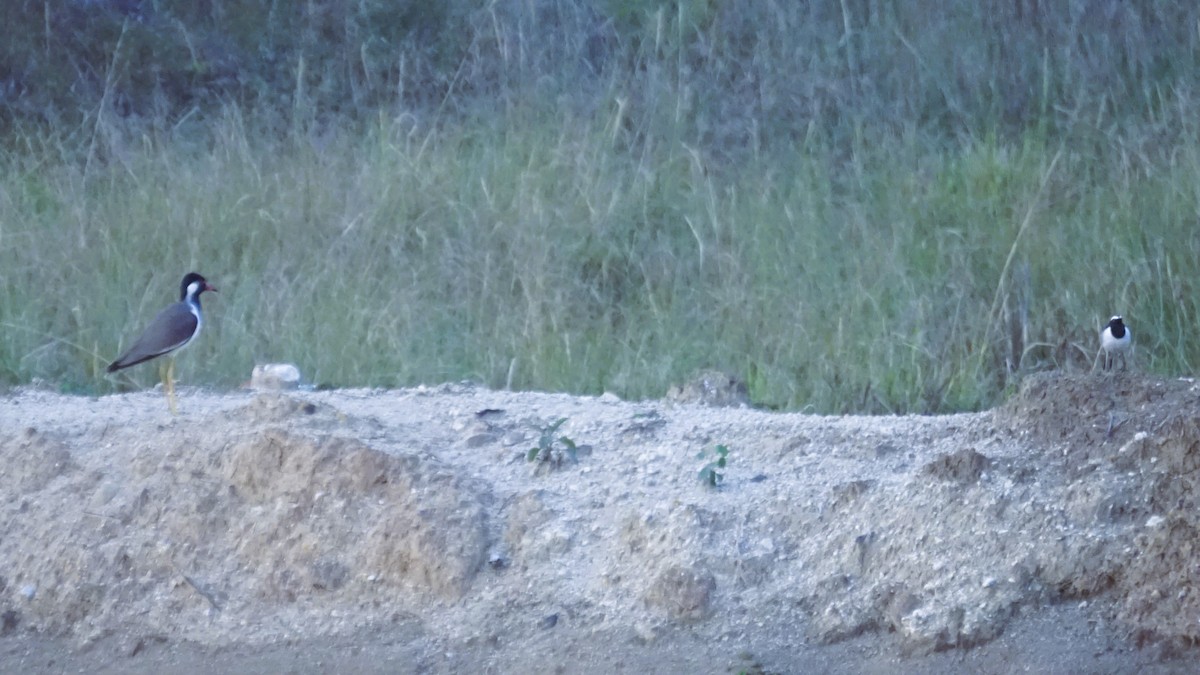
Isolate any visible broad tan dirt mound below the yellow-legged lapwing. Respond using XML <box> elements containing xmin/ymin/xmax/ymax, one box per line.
<box><xmin>0</xmin><ymin>399</ymin><xmax>486</xmax><ymax>637</ymax></box>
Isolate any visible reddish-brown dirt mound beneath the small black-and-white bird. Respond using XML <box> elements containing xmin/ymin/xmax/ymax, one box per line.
<box><xmin>997</xmin><ymin>375</ymin><xmax>1200</xmax><ymax>644</ymax></box>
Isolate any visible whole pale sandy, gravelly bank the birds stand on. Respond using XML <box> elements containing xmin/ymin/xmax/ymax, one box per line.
<box><xmin>0</xmin><ymin>375</ymin><xmax>1200</xmax><ymax>673</ymax></box>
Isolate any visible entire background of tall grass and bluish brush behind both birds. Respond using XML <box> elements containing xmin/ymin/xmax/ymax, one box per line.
<box><xmin>0</xmin><ymin>0</ymin><xmax>1200</xmax><ymax>413</ymax></box>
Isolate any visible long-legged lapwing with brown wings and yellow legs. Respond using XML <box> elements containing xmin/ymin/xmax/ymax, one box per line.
<box><xmin>108</xmin><ymin>271</ymin><xmax>216</xmax><ymax>414</ymax></box>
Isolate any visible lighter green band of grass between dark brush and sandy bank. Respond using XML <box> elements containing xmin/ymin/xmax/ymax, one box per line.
<box><xmin>0</xmin><ymin>102</ymin><xmax>1200</xmax><ymax>412</ymax></box>
